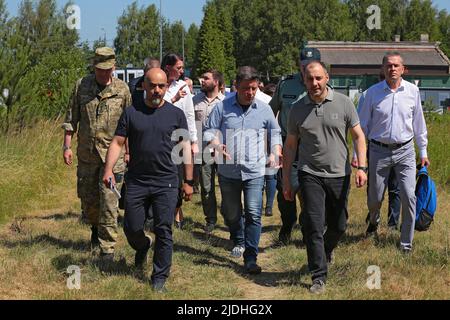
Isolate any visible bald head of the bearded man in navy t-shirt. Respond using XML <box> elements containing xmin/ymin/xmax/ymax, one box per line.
<box><xmin>144</xmin><ymin>68</ymin><xmax>168</xmax><ymax>108</ymax></box>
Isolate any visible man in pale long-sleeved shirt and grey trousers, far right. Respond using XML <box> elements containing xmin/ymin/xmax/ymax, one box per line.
<box><xmin>359</xmin><ymin>52</ymin><xmax>430</xmax><ymax>253</ymax></box>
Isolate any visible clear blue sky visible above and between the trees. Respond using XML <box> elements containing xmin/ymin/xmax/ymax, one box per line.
<box><xmin>6</xmin><ymin>0</ymin><xmax>450</xmax><ymax>45</ymax></box>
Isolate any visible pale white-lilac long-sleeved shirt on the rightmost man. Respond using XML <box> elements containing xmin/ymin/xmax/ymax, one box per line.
<box><xmin>358</xmin><ymin>80</ymin><xmax>428</xmax><ymax>158</ymax></box>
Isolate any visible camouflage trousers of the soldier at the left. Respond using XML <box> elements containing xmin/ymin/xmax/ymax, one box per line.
<box><xmin>77</xmin><ymin>157</ymin><xmax>123</xmax><ymax>253</ymax></box>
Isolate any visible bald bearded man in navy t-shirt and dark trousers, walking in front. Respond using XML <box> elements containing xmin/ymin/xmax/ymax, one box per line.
<box><xmin>103</xmin><ymin>68</ymin><xmax>194</xmax><ymax>291</ymax></box>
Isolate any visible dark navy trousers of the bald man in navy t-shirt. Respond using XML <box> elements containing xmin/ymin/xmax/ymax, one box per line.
<box><xmin>123</xmin><ymin>179</ymin><xmax>178</xmax><ymax>283</ymax></box>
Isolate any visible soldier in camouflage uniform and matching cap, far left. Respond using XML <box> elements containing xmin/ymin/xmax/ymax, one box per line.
<box><xmin>62</xmin><ymin>47</ymin><xmax>131</xmax><ymax>261</ymax></box>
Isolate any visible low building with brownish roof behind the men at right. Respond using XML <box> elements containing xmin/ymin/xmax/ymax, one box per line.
<box><xmin>307</xmin><ymin>39</ymin><xmax>450</xmax><ymax>108</ymax></box>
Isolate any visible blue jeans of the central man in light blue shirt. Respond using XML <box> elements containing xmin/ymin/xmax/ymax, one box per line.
<box><xmin>219</xmin><ymin>175</ymin><xmax>264</xmax><ymax>263</ymax></box>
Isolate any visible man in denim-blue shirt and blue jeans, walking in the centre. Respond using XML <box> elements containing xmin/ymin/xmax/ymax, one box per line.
<box><xmin>204</xmin><ymin>67</ymin><xmax>282</xmax><ymax>274</ymax></box>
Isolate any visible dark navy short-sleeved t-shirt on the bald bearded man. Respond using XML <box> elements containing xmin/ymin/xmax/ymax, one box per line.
<box><xmin>116</xmin><ymin>102</ymin><xmax>189</xmax><ymax>188</ymax></box>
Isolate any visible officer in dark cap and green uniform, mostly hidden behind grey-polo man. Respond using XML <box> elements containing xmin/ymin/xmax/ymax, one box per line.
<box><xmin>270</xmin><ymin>48</ymin><xmax>320</xmax><ymax>244</ymax></box>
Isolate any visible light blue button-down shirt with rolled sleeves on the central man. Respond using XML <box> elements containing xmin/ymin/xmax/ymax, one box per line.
<box><xmin>204</xmin><ymin>96</ymin><xmax>282</xmax><ymax>181</ymax></box>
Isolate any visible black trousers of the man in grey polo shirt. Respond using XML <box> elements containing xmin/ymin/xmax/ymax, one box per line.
<box><xmin>299</xmin><ymin>171</ymin><xmax>350</xmax><ymax>282</ymax></box>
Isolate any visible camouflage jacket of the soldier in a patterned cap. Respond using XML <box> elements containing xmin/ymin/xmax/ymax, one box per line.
<box><xmin>62</xmin><ymin>75</ymin><xmax>131</xmax><ymax>172</ymax></box>
